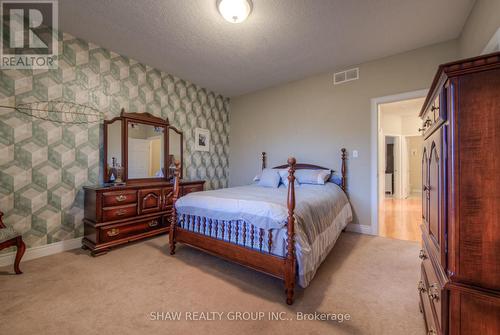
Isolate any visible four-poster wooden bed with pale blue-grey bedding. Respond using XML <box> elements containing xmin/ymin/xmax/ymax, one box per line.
<box><xmin>169</xmin><ymin>149</ymin><xmax>352</xmax><ymax>304</ymax></box>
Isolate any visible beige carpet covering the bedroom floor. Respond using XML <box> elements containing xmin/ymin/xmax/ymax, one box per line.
<box><xmin>0</xmin><ymin>233</ymin><xmax>425</xmax><ymax>335</ymax></box>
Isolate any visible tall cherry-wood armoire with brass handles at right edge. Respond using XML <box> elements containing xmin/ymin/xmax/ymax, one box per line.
<box><xmin>418</xmin><ymin>53</ymin><xmax>500</xmax><ymax>335</ymax></box>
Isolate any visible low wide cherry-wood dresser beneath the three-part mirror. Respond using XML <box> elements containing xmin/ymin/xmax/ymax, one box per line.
<box><xmin>82</xmin><ymin>180</ymin><xmax>205</xmax><ymax>256</ymax></box>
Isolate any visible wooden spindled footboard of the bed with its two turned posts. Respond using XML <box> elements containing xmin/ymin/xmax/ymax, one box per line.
<box><xmin>169</xmin><ymin>157</ymin><xmax>296</xmax><ymax>305</ymax></box>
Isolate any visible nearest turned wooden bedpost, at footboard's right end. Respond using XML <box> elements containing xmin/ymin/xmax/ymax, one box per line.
<box><xmin>285</xmin><ymin>157</ymin><xmax>297</xmax><ymax>305</ymax></box>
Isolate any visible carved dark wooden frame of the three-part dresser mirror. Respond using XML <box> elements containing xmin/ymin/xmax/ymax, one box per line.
<box><xmin>103</xmin><ymin>108</ymin><xmax>184</xmax><ymax>183</ymax></box>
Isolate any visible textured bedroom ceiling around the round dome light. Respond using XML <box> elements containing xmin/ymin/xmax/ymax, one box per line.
<box><xmin>59</xmin><ymin>0</ymin><xmax>474</xmax><ymax>96</ymax></box>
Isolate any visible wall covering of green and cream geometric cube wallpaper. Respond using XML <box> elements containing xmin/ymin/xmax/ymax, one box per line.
<box><xmin>0</xmin><ymin>33</ymin><xmax>229</xmax><ymax>252</ymax></box>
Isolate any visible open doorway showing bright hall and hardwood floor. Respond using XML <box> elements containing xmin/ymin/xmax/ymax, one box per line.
<box><xmin>377</xmin><ymin>97</ymin><xmax>424</xmax><ymax>241</ymax></box>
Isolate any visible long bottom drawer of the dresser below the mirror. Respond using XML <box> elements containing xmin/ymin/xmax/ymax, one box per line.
<box><xmin>99</xmin><ymin>217</ymin><xmax>165</xmax><ymax>243</ymax></box>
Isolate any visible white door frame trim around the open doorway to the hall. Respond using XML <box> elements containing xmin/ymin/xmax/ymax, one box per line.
<box><xmin>371</xmin><ymin>89</ymin><xmax>429</xmax><ymax>235</ymax></box>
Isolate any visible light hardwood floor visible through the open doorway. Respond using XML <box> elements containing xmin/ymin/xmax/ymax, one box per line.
<box><xmin>379</xmin><ymin>195</ymin><xmax>422</xmax><ymax>242</ymax></box>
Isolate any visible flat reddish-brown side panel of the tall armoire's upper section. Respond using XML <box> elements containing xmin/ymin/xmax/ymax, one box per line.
<box><xmin>455</xmin><ymin>69</ymin><xmax>500</xmax><ymax>290</ymax></box>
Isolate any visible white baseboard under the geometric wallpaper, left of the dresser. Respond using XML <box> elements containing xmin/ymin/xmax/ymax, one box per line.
<box><xmin>0</xmin><ymin>237</ymin><xmax>82</xmax><ymax>266</ymax></box>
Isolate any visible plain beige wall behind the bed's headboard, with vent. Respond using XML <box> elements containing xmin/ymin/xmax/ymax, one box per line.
<box><xmin>230</xmin><ymin>41</ymin><xmax>458</xmax><ymax>225</ymax></box>
